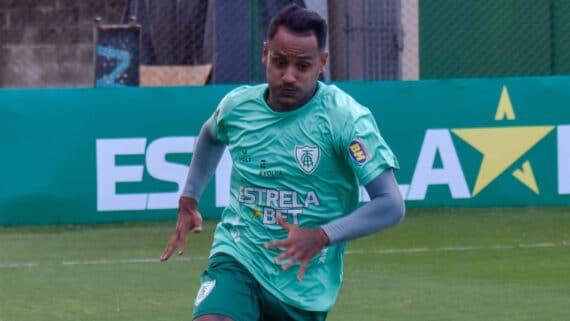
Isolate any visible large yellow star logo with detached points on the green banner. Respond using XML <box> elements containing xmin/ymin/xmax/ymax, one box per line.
<box><xmin>451</xmin><ymin>86</ymin><xmax>554</xmax><ymax>196</ymax></box>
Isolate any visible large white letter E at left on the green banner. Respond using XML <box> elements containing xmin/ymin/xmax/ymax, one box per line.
<box><xmin>96</xmin><ymin>138</ymin><xmax>146</xmax><ymax>211</ymax></box>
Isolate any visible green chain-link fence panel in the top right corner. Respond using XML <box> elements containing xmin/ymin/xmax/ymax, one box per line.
<box><xmin>419</xmin><ymin>0</ymin><xmax>570</xmax><ymax>78</ymax></box>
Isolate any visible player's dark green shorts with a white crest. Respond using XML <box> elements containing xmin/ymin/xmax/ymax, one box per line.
<box><xmin>192</xmin><ymin>253</ymin><xmax>327</xmax><ymax>321</ymax></box>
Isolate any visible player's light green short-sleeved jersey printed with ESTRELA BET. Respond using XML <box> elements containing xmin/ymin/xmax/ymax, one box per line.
<box><xmin>206</xmin><ymin>82</ymin><xmax>398</xmax><ymax>311</ymax></box>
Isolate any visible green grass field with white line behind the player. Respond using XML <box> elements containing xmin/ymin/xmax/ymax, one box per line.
<box><xmin>0</xmin><ymin>208</ymin><xmax>570</xmax><ymax>321</ymax></box>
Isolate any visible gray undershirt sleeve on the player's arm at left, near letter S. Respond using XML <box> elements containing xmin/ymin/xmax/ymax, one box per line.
<box><xmin>181</xmin><ymin>121</ymin><xmax>226</xmax><ymax>202</ymax></box>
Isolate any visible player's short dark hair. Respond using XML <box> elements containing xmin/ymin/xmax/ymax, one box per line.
<box><xmin>267</xmin><ymin>4</ymin><xmax>327</xmax><ymax>50</ymax></box>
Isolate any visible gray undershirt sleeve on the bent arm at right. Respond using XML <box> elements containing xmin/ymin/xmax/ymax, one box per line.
<box><xmin>321</xmin><ymin>168</ymin><xmax>405</xmax><ymax>244</ymax></box>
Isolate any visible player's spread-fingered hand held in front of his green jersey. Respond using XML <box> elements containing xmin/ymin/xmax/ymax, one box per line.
<box><xmin>265</xmin><ymin>215</ymin><xmax>329</xmax><ymax>281</ymax></box>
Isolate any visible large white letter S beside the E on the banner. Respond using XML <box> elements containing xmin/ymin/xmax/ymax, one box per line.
<box><xmin>146</xmin><ymin>137</ymin><xmax>195</xmax><ymax>210</ymax></box>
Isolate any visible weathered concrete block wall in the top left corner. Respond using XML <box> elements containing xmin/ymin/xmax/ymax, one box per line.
<box><xmin>0</xmin><ymin>0</ymin><xmax>125</xmax><ymax>88</ymax></box>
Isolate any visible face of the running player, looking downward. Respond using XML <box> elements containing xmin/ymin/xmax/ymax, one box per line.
<box><xmin>262</xmin><ymin>27</ymin><xmax>328</xmax><ymax>111</ymax></box>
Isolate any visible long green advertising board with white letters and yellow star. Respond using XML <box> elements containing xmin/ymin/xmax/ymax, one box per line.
<box><xmin>0</xmin><ymin>77</ymin><xmax>570</xmax><ymax>225</ymax></box>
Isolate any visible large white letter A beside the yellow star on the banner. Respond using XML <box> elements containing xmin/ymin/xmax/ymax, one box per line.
<box><xmin>406</xmin><ymin>129</ymin><xmax>471</xmax><ymax>200</ymax></box>
